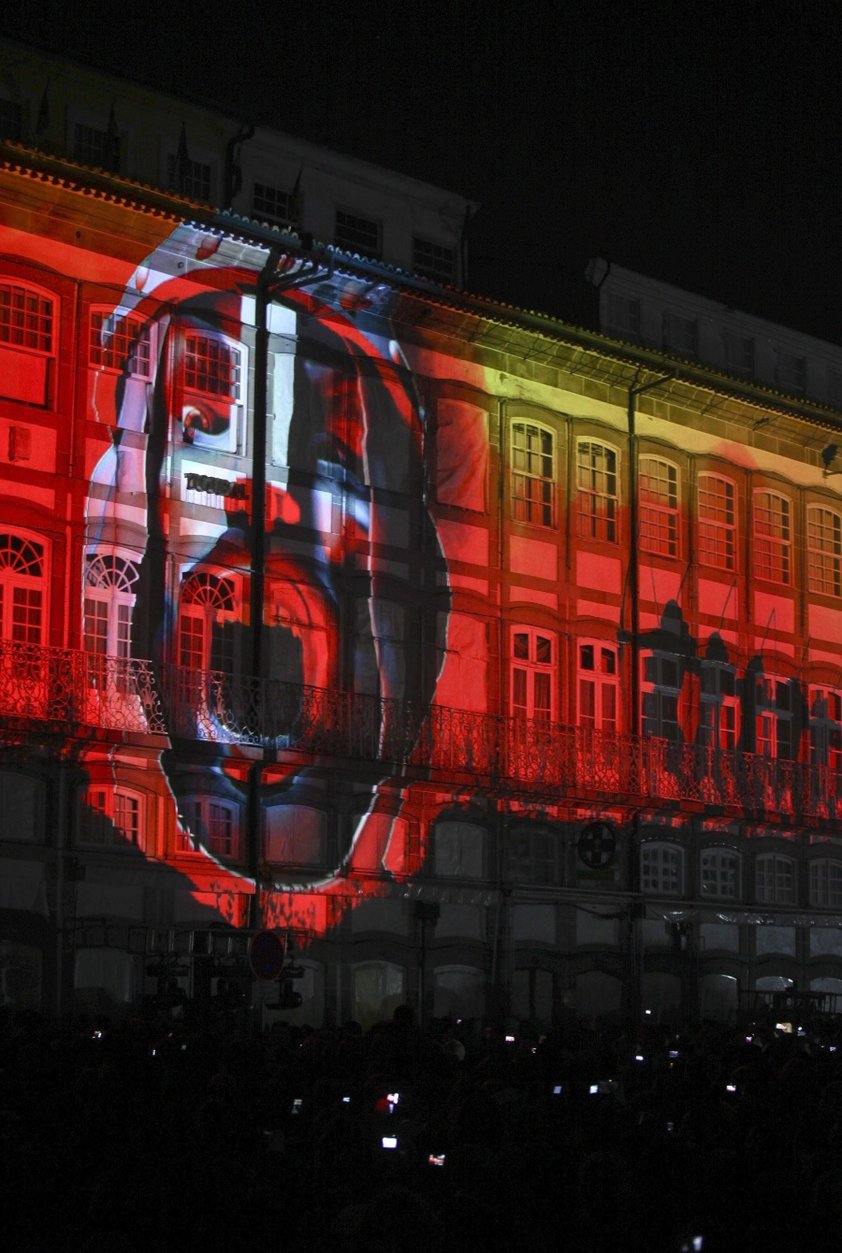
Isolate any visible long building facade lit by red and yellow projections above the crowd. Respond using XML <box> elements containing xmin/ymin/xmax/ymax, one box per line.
<box><xmin>0</xmin><ymin>147</ymin><xmax>842</xmax><ymax>1025</ymax></box>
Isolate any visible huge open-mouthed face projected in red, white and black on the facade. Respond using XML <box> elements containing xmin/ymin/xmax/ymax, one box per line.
<box><xmin>86</xmin><ymin>228</ymin><xmax>449</xmax><ymax>925</ymax></box>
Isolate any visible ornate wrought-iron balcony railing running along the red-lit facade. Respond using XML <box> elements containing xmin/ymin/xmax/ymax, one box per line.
<box><xmin>0</xmin><ymin>643</ymin><xmax>842</xmax><ymax>819</ymax></box>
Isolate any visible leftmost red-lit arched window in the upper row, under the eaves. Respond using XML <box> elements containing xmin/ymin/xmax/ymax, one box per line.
<box><xmin>0</xmin><ymin>282</ymin><xmax>55</xmax><ymax>405</ymax></box>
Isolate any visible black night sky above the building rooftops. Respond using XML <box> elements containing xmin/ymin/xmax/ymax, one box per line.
<box><xmin>1</xmin><ymin>0</ymin><xmax>842</xmax><ymax>342</ymax></box>
